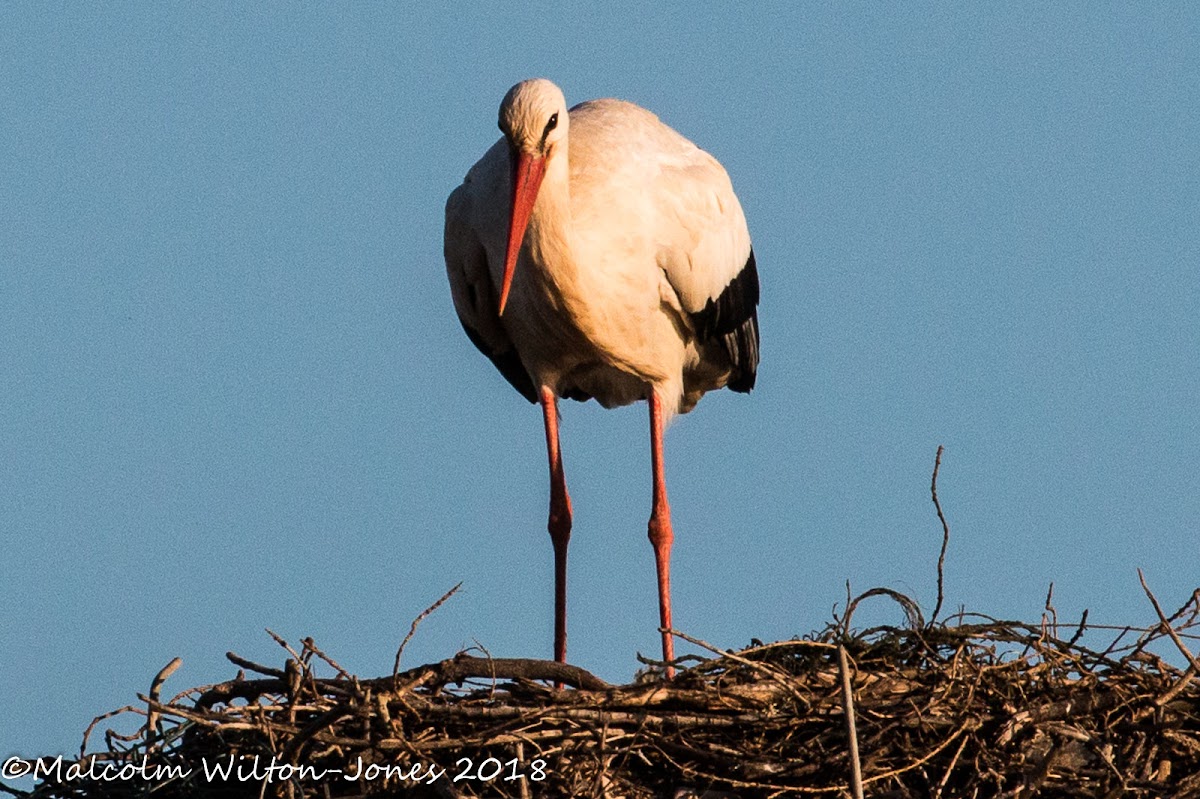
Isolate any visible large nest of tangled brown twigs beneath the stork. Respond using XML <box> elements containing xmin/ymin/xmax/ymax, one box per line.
<box><xmin>8</xmin><ymin>575</ymin><xmax>1200</xmax><ymax>799</ymax></box>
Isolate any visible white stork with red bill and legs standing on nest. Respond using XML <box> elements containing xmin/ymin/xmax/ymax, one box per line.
<box><xmin>445</xmin><ymin>79</ymin><xmax>758</xmax><ymax>677</ymax></box>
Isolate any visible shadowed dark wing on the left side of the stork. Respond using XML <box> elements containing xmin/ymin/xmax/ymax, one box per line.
<box><xmin>444</xmin><ymin>176</ymin><xmax>538</xmax><ymax>402</ymax></box>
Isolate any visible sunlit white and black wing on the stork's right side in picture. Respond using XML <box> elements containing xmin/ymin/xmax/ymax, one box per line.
<box><xmin>655</xmin><ymin>148</ymin><xmax>758</xmax><ymax>391</ymax></box>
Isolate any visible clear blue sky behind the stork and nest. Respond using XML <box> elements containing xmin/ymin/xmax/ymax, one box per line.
<box><xmin>0</xmin><ymin>2</ymin><xmax>1200</xmax><ymax>755</ymax></box>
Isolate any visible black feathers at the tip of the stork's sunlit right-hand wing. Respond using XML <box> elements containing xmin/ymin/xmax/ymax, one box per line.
<box><xmin>690</xmin><ymin>250</ymin><xmax>758</xmax><ymax>394</ymax></box>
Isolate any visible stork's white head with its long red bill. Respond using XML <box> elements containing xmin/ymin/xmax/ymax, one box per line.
<box><xmin>499</xmin><ymin>78</ymin><xmax>569</xmax><ymax>313</ymax></box>
